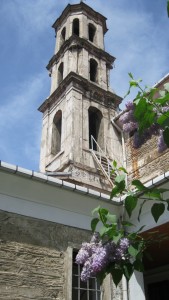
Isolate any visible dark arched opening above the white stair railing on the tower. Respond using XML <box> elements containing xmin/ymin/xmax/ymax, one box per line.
<box><xmin>88</xmin><ymin>106</ymin><xmax>104</xmax><ymax>151</ymax></box>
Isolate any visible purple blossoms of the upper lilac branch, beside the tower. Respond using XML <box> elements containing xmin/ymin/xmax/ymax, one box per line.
<box><xmin>120</xmin><ymin>101</ymin><xmax>169</xmax><ymax>153</ymax></box>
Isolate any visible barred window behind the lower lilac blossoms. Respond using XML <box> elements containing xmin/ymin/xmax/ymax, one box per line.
<box><xmin>72</xmin><ymin>251</ymin><xmax>101</xmax><ymax>300</ymax></box>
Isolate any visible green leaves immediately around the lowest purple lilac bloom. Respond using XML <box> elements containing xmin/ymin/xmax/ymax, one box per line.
<box><xmin>91</xmin><ymin>206</ymin><xmax>145</xmax><ymax>286</ymax></box>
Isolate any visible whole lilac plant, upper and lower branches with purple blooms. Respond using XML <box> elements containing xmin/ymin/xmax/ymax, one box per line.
<box><xmin>76</xmin><ymin>0</ymin><xmax>169</xmax><ymax>285</ymax></box>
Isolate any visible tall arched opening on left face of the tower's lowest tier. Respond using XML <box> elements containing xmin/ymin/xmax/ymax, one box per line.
<box><xmin>52</xmin><ymin>110</ymin><xmax>62</xmax><ymax>155</ymax></box>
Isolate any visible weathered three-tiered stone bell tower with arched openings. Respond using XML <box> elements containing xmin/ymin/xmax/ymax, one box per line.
<box><xmin>39</xmin><ymin>2</ymin><xmax>122</xmax><ymax>190</ymax></box>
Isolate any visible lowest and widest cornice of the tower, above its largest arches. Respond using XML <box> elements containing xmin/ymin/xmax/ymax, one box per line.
<box><xmin>38</xmin><ymin>72</ymin><xmax>122</xmax><ymax>113</ymax></box>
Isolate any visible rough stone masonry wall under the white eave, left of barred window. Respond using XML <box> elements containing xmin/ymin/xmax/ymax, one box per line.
<box><xmin>0</xmin><ymin>211</ymin><xmax>90</xmax><ymax>300</ymax></box>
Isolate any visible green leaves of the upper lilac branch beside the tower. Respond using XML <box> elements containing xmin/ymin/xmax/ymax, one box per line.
<box><xmin>127</xmin><ymin>73</ymin><xmax>169</xmax><ymax>147</ymax></box>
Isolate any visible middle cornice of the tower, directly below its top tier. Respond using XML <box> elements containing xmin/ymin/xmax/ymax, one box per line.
<box><xmin>46</xmin><ymin>35</ymin><xmax>116</xmax><ymax>70</ymax></box>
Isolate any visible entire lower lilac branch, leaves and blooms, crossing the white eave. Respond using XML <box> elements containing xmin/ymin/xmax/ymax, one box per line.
<box><xmin>76</xmin><ymin>161</ymin><xmax>169</xmax><ymax>285</ymax></box>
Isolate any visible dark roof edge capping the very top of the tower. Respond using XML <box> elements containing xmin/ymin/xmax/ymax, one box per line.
<box><xmin>52</xmin><ymin>2</ymin><xmax>108</xmax><ymax>34</ymax></box>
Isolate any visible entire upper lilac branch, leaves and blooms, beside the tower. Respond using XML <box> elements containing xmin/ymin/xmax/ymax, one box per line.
<box><xmin>119</xmin><ymin>73</ymin><xmax>169</xmax><ymax>153</ymax></box>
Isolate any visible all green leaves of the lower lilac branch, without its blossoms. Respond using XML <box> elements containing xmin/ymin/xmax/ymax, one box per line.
<box><xmin>87</xmin><ymin>157</ymin><xmax>169</xmax><ymax>286</ymax></box>
